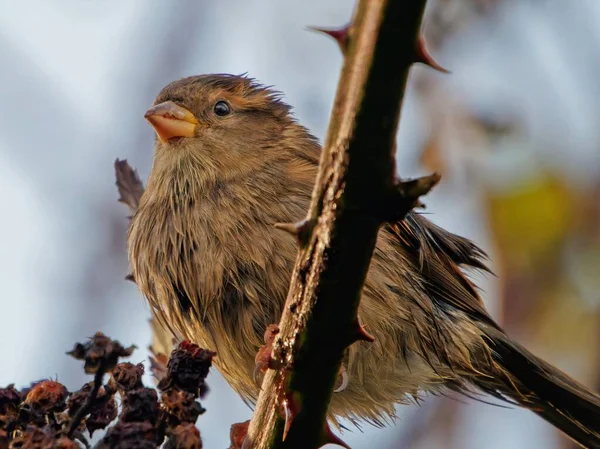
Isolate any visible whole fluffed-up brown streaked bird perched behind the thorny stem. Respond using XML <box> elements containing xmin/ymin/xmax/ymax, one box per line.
<box><xmin>128</xmin><ymin>75</ymin><xmax>600</xmax><ymax>448</ymax></box>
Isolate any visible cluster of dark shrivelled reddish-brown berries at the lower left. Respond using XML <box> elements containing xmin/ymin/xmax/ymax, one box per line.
<box><xmin>0</xmin><ymin>333</ymin><xmax>215</xmax><ymax>449</ymax></box>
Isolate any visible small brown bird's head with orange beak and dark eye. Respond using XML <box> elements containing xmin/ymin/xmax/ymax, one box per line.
<box><xmin>145</xmin><ymin>74</ymin><xmax>314</xmax><ymax>186</ymax></box>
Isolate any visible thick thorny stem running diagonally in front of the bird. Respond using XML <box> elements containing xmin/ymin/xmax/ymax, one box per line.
<box><xmin>244</xmin><ymin>0</ymin><xmax>439</xmax><ymax>449</ymax></box>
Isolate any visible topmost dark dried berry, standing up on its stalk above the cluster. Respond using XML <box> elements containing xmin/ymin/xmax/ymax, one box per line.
<box><xmin>67</xmin><ymin>332</ymin><xmax>135</xmax><ymax>374</ymax></box>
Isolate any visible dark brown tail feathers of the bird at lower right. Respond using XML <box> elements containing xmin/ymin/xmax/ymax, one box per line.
<box><xmin>475</xmin><ymin>329</ymin><xmax>600</xmax><ymax>449</ymax></box>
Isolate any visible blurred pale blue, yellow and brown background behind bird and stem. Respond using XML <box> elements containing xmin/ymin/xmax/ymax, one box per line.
<box><xmin>0</xmin><ymin>0</ymin><xmax>600</xmax><ymax>449</ymax></box>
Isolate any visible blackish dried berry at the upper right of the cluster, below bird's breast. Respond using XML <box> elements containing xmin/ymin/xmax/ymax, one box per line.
<box><xmin>158</xmin><ymin>340</ymin><xmax>216</xmax><ymax>397</ymax></box>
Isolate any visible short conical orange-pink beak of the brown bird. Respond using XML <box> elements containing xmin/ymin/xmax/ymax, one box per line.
<box><xmin>144</xmin><ymin>101</ymin><xmax>198</xmax><ymax>143</ymax></box>
